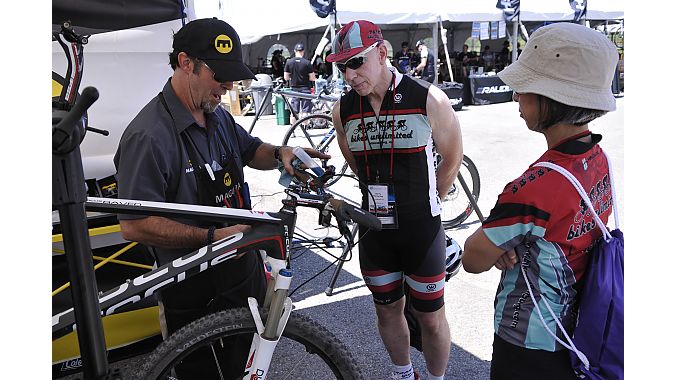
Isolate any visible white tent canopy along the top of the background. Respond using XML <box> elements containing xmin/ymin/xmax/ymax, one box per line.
<box><xmin>195</xmin><ymin>0</ymin><xmax>624</xmax><ymax>44</ymax></box>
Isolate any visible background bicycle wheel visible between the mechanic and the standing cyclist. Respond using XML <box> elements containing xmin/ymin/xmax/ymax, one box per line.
<box><xmin>282</xmin><ymin>114</ymin><xmax>348</xmax><ymax>187</ymax></box>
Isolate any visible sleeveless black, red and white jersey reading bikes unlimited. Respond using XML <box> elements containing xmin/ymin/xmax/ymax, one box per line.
<box><xmin>340</xmin><ymin>72</ymin><xmax>441</xmax><ymax>219</ymax></box>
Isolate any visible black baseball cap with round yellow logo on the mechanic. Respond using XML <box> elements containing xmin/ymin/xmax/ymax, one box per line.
<box><xmin>172</xmin><ymin>17</ymin><xmax>255</xmax><ymax>82</ymax></box>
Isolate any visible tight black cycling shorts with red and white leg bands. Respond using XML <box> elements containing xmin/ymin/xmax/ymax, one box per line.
<box><xmin>359</xmin><ymin>216</ymin><xmax>446</xmax><ymax>312</ymax></box>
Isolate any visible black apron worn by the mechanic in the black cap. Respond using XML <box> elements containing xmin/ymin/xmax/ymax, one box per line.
<box><xmin>159</xmin><ymin>93</ymin><xmax>266</xmax><ymax>379</ymax></box>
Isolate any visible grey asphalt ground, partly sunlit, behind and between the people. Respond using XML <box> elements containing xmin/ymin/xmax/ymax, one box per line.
<box><xmin>62</xmin><ymin>98</ymin><xmax>624</xmax><ymax>380</ymax></box>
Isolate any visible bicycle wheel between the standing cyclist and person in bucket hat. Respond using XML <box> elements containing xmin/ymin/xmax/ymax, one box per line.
<box><xmin>441</xmin><ymin>156</ymin><xmax>481</xmax><ymax>229</ymax></box>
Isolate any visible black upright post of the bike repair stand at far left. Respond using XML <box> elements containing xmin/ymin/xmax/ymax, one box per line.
<box><xmin>52</xmin><ymin>87</ymin><xmax>119</xmax><ymax>379</ymax></box>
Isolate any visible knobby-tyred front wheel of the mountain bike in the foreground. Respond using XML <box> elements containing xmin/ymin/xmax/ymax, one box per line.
<box><xmin>138</xmin><ymin>308</ymin><xmax>364</xmax><ymax>380</ymax></box>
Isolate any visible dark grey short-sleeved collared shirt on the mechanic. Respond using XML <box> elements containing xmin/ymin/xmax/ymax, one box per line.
<box><xmin>114</xmin><ymin>79</ymin><xmax>262</xmax><ymax>258</ymax></box>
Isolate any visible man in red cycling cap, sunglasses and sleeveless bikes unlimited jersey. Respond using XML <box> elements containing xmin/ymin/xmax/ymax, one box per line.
<box><xmin>326</xmin><ymin>20</ymin><xmax>462</xmax><ymax>380</ymax></box>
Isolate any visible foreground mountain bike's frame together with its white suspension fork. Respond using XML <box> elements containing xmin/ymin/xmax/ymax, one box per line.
<box><xmin>52</xmin><ymin>176</ymin><xmax>372</xmax><ymax>379</ymax></box>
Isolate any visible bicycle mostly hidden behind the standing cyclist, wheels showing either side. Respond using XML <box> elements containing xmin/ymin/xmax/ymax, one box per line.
<box><xmin>282</xmin><ymin>114</ymin><xmax>484</xmax><ymax>229</ymax></box>
